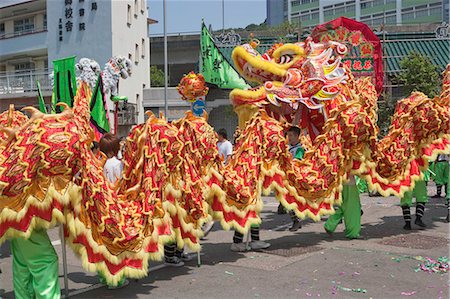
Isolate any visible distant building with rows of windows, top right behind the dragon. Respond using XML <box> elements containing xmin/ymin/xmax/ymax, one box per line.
<box><xmin>267</xmin><ymin>0</ymin><xmax>449</xmax><ymax>28</ymax></box>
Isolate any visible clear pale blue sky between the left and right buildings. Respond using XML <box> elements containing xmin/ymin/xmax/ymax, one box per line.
<box><xmin>148</xmin><ymin>0</ymin><xmax>266</xmax><ymax>35</ymax></box>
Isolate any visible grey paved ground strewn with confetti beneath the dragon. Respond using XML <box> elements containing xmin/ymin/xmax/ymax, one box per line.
<box><xmin>0</xmin><ymin>186</ymin><xmax>450</xmax><ymax>299</ymax></box>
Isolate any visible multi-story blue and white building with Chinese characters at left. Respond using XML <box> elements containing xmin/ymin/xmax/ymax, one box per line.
<box><xmin>0</xmin><ymin>0</ymin><xmax>150</xmax><ymax>133</ymax></box>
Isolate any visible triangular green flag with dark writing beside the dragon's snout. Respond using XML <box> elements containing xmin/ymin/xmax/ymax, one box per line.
<box><xmin>200</xmin><ymin>23</ymin><xmax>250</xmax><ymax>89</ymax></box>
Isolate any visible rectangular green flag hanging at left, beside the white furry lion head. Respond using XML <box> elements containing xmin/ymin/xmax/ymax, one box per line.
<box><xmin>52</xmin><ymin>56</ymin><xmax>77</xmax><ymax>113</ymax></box>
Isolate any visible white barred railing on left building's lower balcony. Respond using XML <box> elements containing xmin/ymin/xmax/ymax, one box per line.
<box><xmin>0</xmin><ymin>70</ymin><xmax>52</xmax><ymax>94</ymax></box>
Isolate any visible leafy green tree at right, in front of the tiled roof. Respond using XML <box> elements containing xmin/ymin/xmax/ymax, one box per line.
<box><xmin>397</xmin><ymin>51</ymin><xmax>440</xmax><ymax>97</ymax></box>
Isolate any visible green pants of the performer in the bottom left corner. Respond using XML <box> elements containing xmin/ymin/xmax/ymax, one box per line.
<box><xmin>11</xmin><ymin>230</ymin><xmax>60</xmax><ymax>299</ymax></box>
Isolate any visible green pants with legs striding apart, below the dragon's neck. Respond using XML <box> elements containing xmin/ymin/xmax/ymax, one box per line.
<box><xmin>324</xmin><ymin>185</ymin><xmax>361</xmax><ymax>239</ymax></box>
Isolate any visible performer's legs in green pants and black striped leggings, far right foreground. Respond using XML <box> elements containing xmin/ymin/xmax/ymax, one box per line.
<box><xmin>400</xmin><ymin>180</ymin><xmax>428</xmax><ymax>230</ymax></box>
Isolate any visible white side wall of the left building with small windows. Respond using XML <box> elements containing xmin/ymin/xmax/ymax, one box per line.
<box><xmin>111</xmin><ymin>0</ymin><xmax>150</xmax><ymax>123</ymax></box>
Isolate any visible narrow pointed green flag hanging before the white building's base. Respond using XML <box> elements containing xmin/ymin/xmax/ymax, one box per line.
<box><xmin>90</xmin><ymin>75</ymin><xmax>110</xmax><ymax>135</ymax></box>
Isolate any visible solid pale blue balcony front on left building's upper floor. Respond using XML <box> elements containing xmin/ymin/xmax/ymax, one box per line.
<box><xmin>0</xmin><ymin>28</ymin><xmax>47</xmax><ymax>59</ymax></box>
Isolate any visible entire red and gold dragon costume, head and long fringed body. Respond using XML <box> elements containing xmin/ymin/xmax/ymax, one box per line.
<box><xmin>0</xmin><ymin>40</ymin><xmax>450</xmax><ymax>283</ymax></box>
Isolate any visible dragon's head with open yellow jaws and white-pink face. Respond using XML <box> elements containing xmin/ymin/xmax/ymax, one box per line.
<box><xmin>230</xmin><ymin>38</ymin><xmax>349</xmax><ymax>136</ymax></box>
